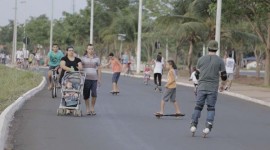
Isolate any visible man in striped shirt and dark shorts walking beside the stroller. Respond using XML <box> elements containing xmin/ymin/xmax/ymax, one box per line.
<box><xmin>82</xmin><ymin>44</ymin><xmax>101</xmax><ymax>115</ymax></box>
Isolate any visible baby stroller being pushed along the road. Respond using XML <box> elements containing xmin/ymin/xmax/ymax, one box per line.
<box><xmin>57</xmin><ymin>71</ymin><xmax>86</xmax><ymax>117</ymax></box>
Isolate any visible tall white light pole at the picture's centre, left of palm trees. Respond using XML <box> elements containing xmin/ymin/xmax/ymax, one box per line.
<box><xmin>137</xmin><ymin>0</ymin><xmax>142</xmax><ymax>73</ymax></box>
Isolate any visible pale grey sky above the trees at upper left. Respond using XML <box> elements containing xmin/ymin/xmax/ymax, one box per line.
<box><xmin>0</xmin><ymin>0</ymin><xmax>87</xmax><ymax>26</ymax></box>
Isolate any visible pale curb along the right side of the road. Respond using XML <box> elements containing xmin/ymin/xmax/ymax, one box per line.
<box><xmin>102</xmin><ymin>71</ymin><xmax>270</xmax><ymax>107</ymax></box>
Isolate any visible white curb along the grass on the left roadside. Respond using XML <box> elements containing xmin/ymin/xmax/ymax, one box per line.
<box><xmin>0</xmin><ymin>77</ymin><xmax>46</xmax><ymax>150</ymax></box>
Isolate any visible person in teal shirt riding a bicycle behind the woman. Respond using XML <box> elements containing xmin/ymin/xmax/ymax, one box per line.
<box><xmin>44</xmin><ymin>44</ymin><xmax>64</xmax><ymax>90</ymax></box>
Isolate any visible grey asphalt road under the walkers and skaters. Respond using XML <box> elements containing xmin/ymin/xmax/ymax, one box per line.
<box><xmin>5</xmin><ymin>74</ymin><xmax>270</xmax><ymax>150</ymax></box>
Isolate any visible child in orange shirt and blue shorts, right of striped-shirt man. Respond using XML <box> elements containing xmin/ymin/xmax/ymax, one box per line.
<box><xmin>103</xmin><ymin>53</ymin><xmax>122</xmax><ymax>94</ymax></box>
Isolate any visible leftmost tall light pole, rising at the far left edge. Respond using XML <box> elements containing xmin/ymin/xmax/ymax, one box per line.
<box><xmin>12</xmin><ymin>0</ymin><xmax>18</xmax><ymax>65</ymax></box>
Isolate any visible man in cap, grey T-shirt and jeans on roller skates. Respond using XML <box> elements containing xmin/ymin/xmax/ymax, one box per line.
<box><xmin>190</xmin><ymin>40</ymin><xmax>227</xmax><ymax>136</ymax></box>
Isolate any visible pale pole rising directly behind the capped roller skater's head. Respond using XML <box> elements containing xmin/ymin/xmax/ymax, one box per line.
<box><xmin>215</xmin><ymin>0</ymin><xmax>222</xmax><ymax>56</ymax></box>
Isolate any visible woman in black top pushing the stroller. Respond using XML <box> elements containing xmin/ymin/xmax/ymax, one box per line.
<box><xmin>59</xmin><ymin>46</ymin><xmax>82</xmax><ymax>82</ymax></box>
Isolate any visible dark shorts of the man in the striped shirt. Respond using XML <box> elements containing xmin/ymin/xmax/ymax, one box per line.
<box><xmin>83</xmin><ymin>79</ymin><xmax>97</xmax><ymax>99</ymax></box>
